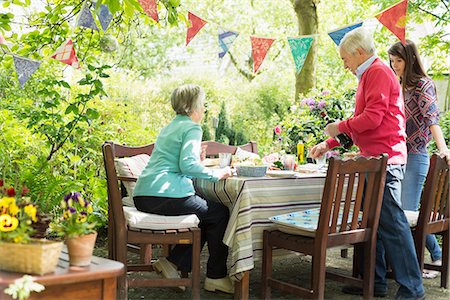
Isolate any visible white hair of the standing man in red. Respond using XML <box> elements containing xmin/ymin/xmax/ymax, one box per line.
<box><xmin>339</xmin><ymin>27</ymin><xmax>376</xmax><ymax>54</ymax></box>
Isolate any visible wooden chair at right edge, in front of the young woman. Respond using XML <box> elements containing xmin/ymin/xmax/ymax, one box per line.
<box><xmin>405</xmin><ymin>154</ymin><xmax>450</xmax><ymax>289</ymax></box>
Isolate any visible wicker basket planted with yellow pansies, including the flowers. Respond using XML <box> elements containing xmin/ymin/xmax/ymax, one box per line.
<box><xmin>0</xmin><ymin>180</ymin><xmax>62</xmax><ymax>274</ymax></box>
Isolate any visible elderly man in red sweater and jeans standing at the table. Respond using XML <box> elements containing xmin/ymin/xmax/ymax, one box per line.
<box><xmin>310</xmin><ymin>28</ymin><xmax>425</xmax><ymax>299</ymax></box>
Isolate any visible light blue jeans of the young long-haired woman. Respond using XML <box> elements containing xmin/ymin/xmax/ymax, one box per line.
<box><xmin>402</xmin><ymin>153</ymin><xmax>442</xmax><ymax>261</ymax></box>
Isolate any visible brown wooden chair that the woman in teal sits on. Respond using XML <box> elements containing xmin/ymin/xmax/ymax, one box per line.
<box><xmin>103</xmin><ymin>142</ymin><xmax>201</xmax><ymax>299</ymax></box>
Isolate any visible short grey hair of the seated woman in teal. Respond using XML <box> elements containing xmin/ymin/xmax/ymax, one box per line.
<box><xmin>170</xmin><ymin>84</ymin><xmax>205</xmax><ymax>116</ymax></box>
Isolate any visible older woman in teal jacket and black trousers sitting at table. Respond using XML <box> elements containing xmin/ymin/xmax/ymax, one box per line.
<box><xmin>133</xmin><ymin>84</ymin><xmax>234</xmax><ymax>293</ymax></box>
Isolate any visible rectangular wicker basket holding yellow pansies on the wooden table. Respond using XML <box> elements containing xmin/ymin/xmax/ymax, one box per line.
<box><xmin>0</xmin><ymin>239</ymin><xmax>63</xmax><ymax>275</ymax></box>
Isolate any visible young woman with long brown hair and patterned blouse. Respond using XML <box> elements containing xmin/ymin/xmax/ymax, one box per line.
<box><xmin>388</xmin><ymin>40</ymin><xmax>450</xmax><ymax>278</ymax></box>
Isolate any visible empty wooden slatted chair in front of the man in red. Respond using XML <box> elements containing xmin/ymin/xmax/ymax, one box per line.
<box><xmin>262</xmin><ymin>155</ymin><xmax>387</xmax><ymax>299</ymax></box>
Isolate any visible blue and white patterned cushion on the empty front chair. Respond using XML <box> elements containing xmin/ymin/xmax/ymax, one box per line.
<box><xmin>269</xmin><ymin>208</ymin><xmax>362</xmax><ymax>237</ymax></box>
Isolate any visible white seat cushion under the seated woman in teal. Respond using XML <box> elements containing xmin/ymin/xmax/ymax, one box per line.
<box><xmin>123</xmin><ymin>206</ymin><xmax>200</xmax><ymax>230</ymax></box>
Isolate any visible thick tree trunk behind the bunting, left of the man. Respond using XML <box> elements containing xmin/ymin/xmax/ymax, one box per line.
<box><xmin>291</xmin><ymin>0</ymin><xmax>319</xmax><ymax>99</ymax></box>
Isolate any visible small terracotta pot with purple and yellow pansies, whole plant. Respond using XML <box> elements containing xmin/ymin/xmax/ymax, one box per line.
<box><xmin>51</xmin><ymin>192</ymin><xmax>97</xmax><ymax>266</ymax></box>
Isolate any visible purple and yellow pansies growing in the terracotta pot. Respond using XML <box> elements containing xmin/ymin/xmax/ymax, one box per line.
<box><xmin>51</xmin><ymin>192</ymin><xmax>96</xmax><ymax>237</ymax></box>
